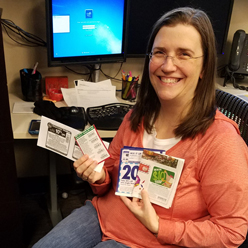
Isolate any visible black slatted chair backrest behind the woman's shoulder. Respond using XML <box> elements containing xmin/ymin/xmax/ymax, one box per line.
<box><xmin>216</xmin><ymin>89</ymin><xmax>248</xmax><ymax>145</ymax></box>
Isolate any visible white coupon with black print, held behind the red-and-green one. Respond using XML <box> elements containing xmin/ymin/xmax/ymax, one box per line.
<box><xmin>37</xmin><ymin>116</ymin><xmax>109</xmax><ymax>172</ymax></box>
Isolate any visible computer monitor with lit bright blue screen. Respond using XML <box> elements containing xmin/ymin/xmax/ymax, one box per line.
<box><xmin>46</xmin><ymin>0</ymin><xmax>129</xmax><ymax>66</ymax></box>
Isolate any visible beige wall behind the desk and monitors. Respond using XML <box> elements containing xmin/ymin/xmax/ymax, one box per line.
<box><xmin>0</xmin><ymin>0</ymin><xmax>248</xmax><ymax>177</ymax></box>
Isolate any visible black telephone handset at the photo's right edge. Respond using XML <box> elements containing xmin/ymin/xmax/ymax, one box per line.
<box><xmin>228</xmin><ymin>29</ymin><xmax>248</xmax><ymax>75</ymax></box>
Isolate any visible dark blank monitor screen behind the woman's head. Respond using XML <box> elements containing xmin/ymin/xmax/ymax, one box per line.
<box><xmin>127</xmin><ymin>0</ymin><xmax>233</xmax><ymax>58</ymax></box>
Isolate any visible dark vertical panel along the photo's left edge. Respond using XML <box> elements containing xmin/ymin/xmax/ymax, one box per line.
<box><xmin>0</xmin><ymin>9</ymin><xmax>22</xmax><ymax>248</ymax></box>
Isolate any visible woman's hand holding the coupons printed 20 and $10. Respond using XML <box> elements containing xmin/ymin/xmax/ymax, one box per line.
<box><xmin>120</xmin><ymin>190</ymin><xmax>159</xmax><ymax>234</ymax></box>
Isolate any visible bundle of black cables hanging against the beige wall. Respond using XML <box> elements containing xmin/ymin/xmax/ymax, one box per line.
<box><xmin>1</xmin><ymin>19</ymin><xmax>46</xmax><ymax>47</ymax></box>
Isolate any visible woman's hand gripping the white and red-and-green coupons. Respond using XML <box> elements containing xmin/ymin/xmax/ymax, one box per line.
<box><xmin>73</xmin><ymin>154</ymin><xmax>105</xmax><ymax>184</ymax></box>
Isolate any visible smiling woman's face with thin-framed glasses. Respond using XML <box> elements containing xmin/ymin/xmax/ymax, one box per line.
<box><xmin>149</xmin><ymin>24</ymin><xmax>203</xmax><ymax>105</ymax></box>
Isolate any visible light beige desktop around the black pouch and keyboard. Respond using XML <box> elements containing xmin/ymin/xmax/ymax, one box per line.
<box><xmin>9</xmin><ymin>94</ymin><xmax>123</xmax><ymax>139</ymax></box>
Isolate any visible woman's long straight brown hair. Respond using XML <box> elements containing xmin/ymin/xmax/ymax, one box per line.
<box><xmin>130</xmin><ymin>7</ymin><xmax>216</xmax><ymax>139</ymax></box>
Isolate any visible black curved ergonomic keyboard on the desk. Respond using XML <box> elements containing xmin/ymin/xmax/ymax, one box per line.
<box><xmin>86</xmin><ymin>103</ymin><xmax>133</xmax><ymax>130</ymax></box>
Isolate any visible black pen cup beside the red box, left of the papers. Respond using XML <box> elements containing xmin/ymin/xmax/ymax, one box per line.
<box><xmin>20</xmin><ymin>69</ymin><xmax>42</xmax><ymax>102</ymax></box>
